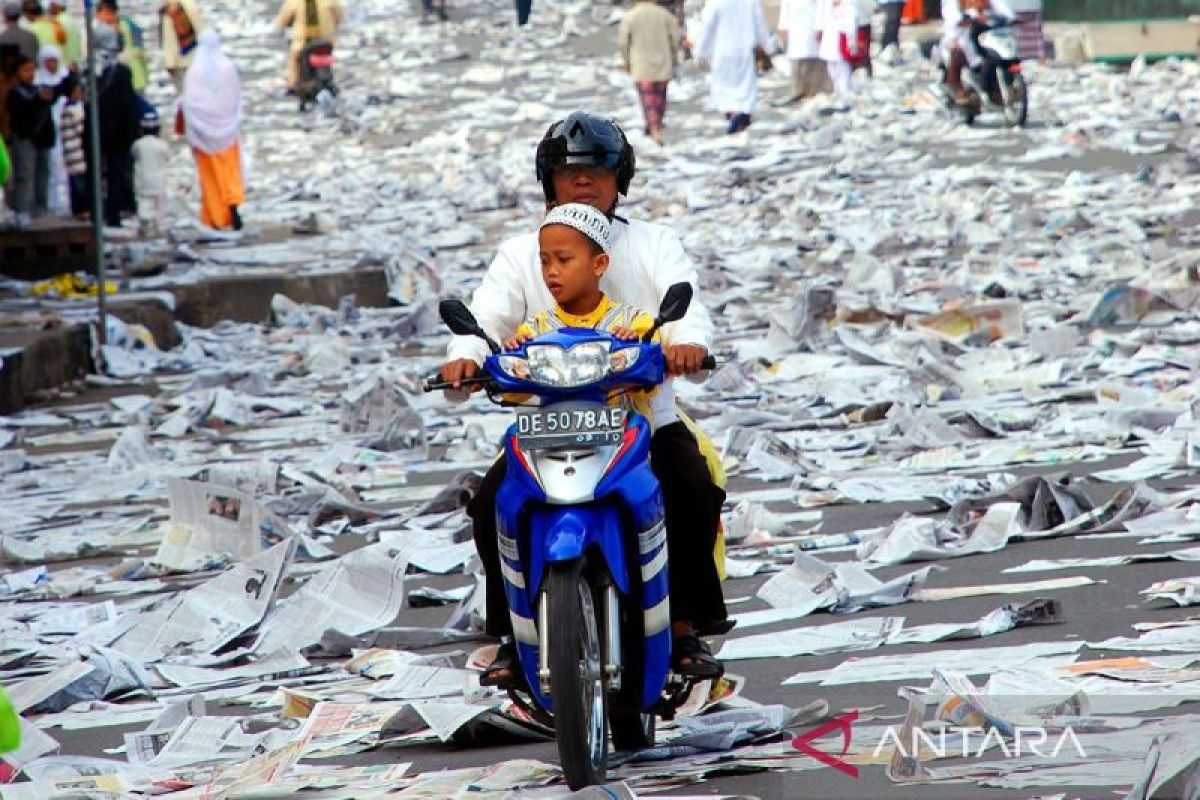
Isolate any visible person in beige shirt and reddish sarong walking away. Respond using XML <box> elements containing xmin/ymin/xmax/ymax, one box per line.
<box><xmin>617</xmin><ymin>0</ymin><xmax>679</xmax><ymax>144</ymax></box>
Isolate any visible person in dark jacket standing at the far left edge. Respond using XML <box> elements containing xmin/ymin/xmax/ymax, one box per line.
<box><xmin>8</xmin><ymin>55</ymin><xmax>55</xmax><ymax>228</ymax></box>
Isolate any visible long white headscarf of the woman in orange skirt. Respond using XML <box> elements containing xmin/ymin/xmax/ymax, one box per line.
<box><xmin>179</xmin><ymin>28</ymin><xmax>241</xmax><ymax>155</ymax></box>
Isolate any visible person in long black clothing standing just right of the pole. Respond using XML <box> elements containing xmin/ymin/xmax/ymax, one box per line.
<box><xmin>84</xmin><ymin>25</ymin><xmax>139</xmax><ymax>228</ymax></box>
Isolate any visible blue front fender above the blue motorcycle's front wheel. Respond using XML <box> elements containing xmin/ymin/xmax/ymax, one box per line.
<box><xmin>529</xmin><ymin>504</ymin><xmax>629</xmax><ymax>596</ymax></box>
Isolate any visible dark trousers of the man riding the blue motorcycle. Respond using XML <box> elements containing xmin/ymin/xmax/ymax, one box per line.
<box><xmin>467</xmin><ymin>422</ymin><xmax>726</xmax><ymax>636</ymax></box>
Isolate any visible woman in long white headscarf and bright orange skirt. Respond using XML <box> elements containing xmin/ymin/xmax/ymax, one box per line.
<box><xmin>180</xmin><ymin>28</ymin><xmax>246</xmax><ymax>230</ymax></box>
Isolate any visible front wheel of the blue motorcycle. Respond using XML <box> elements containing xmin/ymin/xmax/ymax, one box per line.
<box><xmin>546</xmin><ymin>561</ymin><xmax>608</xmax><ymax>789</ymax></box>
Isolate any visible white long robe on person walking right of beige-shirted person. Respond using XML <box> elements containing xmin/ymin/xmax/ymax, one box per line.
<box><xmin>696</xmin><ymin>0</ymin><xmax>770</xmax><ymax>114</ymax></box>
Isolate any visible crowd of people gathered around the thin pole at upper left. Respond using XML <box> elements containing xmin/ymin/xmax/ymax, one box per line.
<box><xmin>0</xmin><ymin>0</ymin><xmax>246</xmax><ymax>235</ymax></box>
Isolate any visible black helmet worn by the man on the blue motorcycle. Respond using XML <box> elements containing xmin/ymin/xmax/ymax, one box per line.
<box><xmin>534</xmin><ymin>112</ymin><xmax>636</xmax><ymax>203</ymax></box>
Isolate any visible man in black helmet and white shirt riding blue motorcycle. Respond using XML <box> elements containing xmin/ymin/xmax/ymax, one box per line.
<box><xmin>440</xmin><ymin>112</ymin><xmax>732</xmax><ymax>686</ymax></box>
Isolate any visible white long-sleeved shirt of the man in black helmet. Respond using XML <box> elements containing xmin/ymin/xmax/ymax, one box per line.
<box><xmin>448</xmin><ymin>219</ymin><xmax>713</xmax><ymax>363</ymax></box>
